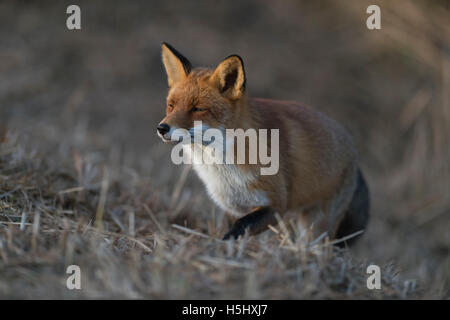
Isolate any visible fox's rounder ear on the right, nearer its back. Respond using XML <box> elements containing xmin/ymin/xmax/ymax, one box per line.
<box><xmin>211</xmin><ymin>55</ymin><xmax>245</xmax><ymax>100</ymax></box>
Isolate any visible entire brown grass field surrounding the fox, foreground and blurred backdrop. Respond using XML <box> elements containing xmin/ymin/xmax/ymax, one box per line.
<box><xmin>0</xmin><ymin>0</ymin><xmax>450</xmax><ymax>299</ymax></box>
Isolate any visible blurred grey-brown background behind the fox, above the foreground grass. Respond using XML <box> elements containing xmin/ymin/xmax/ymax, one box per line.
<box><xmin>0</xmin><ymin>0</ymin><xmax>450</xmax><ymax>298</ymax></box>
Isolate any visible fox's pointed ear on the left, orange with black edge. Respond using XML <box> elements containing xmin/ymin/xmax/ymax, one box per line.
<box><xmin>161</xmin><ymin>42</ymin><xmax>191</xmax><ymax>87</ymax></box>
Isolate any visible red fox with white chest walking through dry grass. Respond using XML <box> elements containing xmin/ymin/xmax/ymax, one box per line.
<box><xmin>157</xmin><ymin>43</ymin><xmax>369</xmax><ymax>244</ymax></box>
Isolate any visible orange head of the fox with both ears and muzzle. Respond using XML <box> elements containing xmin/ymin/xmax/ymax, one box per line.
<box><xmin>157</xmin><ymin>43</ymin><xmax>246</xmax><ymax>142</ymax></box>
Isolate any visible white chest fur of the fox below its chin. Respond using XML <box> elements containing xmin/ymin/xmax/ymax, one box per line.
<box><xmin>183</xmin><ymin>145</ymin><xmax>269</xmax><ymax>217</ymax></box>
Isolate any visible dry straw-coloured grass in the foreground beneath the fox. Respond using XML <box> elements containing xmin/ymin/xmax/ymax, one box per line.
<box><xmin>0</xmin><ymin>137</ymin><xmax>412</xmax><ymax>299</ymax></box>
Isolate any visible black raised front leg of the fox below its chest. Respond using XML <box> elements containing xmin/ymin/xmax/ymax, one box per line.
<box><xmin>223</xmin><ymin>207</ymin><xmax>277</xmax><ymax>240</ymax></box>
